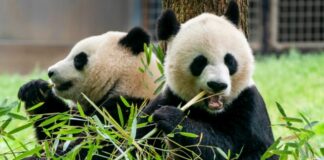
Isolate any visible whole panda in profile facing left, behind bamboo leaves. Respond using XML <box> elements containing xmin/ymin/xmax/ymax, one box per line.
<box><xmin>18</xmin><ymin>27</ymin><xmax>159</xmax><ymax>159</ymax></box>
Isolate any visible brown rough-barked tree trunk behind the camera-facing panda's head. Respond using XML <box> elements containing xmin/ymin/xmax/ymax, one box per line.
<box><xmin>162</xmin><ymin>0</ymin><xmax>248</xmax><ymax>37</ymax></box>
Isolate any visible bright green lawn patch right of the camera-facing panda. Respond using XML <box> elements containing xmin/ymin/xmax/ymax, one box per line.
<box><xmin>254</xmin><ymin>50</ymin><xmax>324</xmax><ymax>147</ymax></box>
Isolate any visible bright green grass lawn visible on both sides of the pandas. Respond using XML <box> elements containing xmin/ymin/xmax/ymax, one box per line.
<box><xmin>0</xmin><ymin>51</ymin><xmax>324</xmax><ymax>158</ymax></box>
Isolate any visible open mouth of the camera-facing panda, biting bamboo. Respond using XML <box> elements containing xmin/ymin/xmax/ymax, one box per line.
<box><xmin>204</xmin><ymin>93</ymin><xmax>224</xmax><ymax>110</ymax></box>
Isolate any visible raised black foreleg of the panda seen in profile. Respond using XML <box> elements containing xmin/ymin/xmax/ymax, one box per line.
<box><xmin>18</xmin><ymin>79</ymin><xmax>70</xmax><ymax>141</ymax></box>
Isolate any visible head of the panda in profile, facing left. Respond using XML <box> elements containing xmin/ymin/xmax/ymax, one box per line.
<box><xmin>48</xmin><ymin>27</ymin><xmax>155</xmax><ymax>107</ymax></box>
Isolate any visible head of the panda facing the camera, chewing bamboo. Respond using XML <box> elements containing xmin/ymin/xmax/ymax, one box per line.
<box><xmin>157</xmin><ymin>1</ymin><xmax>254</xmax><ymax>113</ymax></box>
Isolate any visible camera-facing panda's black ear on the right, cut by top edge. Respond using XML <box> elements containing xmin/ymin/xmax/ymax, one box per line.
<box><xmin>224</xmin><ymin>0</ymin><xmax>240</xmax><ymax>26</ymax></box>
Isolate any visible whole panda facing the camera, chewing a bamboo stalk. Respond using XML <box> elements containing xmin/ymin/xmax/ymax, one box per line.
<box><xmin>137</xmin><ymin>1</ymin><xmax>276</xmax><ymax>160</ymax></box>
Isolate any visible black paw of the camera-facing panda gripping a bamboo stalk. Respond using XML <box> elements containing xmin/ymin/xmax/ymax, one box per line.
<box><xmin>153</xmin><ymin>106</ymin><xmax>185</xmax><ymax>134</ymax></box>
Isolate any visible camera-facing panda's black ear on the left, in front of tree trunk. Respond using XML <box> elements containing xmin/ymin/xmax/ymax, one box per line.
<box><xmin>157</xmin><ymin>9</ymin><xmax>180</xmax><ymax>40</ymax></box>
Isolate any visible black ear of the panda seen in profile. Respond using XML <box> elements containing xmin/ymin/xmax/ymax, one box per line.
<box><xmin>119</xmin><ymin>27</ymin><xmax>150</xmax><ymax>55</ymax></box>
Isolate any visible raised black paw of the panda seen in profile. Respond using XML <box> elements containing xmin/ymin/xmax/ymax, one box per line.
<box><xmin>18</xmin><ymin>79</ymin><xmax>53</xmax><ymax>112</ymax></box>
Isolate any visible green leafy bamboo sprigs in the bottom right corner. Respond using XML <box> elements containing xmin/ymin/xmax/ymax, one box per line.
<box><xmin>261</xmin><ymin>103</ymin><xmax>324</xmax><ymax>160</ymax></box>
